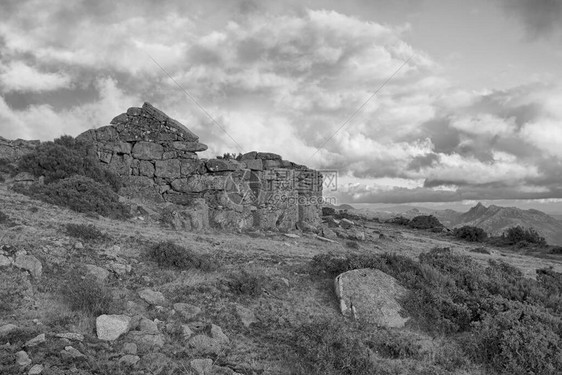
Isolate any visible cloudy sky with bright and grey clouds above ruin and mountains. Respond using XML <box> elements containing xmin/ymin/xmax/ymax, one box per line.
<box><xmin>0</xmin><ymin>0</ymin><xmax>562</xmax><ymax>203</ymax></box>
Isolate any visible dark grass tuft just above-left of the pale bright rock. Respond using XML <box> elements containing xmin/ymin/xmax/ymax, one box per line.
<box><xmin>60</xmin><ymin>271</ymin><xmax>113</xmax><ymax>316</ymax></box>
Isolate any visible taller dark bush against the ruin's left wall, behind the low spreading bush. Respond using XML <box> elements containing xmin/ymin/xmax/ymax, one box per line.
<box><xmin>18</xmin><ymin>135</ymin><xmax>121</xmax><ymax>191</ymax></box>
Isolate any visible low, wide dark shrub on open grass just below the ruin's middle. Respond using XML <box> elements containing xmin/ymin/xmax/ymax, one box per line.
<box><xmin>149</xmin><ymin>241</ymin><xmax>215</xmax><ymax>271</ymax></box>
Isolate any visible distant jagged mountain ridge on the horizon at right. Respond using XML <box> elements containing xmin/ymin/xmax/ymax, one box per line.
<box><xmin>433</xmin><ymin>203</ymin><xmax>562</xmax><ymax>245</ymax></box>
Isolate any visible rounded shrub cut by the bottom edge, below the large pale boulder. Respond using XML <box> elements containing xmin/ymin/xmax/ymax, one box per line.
<box><xmin>292</xmin><ymin>320</ymin><xmax>379</xmax><ymax>375</ymax></box>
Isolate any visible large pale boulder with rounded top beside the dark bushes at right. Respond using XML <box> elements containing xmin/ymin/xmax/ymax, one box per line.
<box><xmin>335</xmin><ymin>268</ymin><xmax>408</xmax><ymax>327</ymax></box>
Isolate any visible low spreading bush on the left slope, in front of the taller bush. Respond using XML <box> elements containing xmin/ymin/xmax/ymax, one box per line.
<box><xmin>14</xmin><ymin>175</ymin><xmax>130</xmax><ymax>219</ymax></box>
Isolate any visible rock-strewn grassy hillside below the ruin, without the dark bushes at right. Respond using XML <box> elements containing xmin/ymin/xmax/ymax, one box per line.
<box><xmin>0</xmin><ymin>184</ymin><xmax>562</xmax><ymax>375</ymax></box>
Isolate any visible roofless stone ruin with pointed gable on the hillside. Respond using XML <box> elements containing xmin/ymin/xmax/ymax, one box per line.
<box><xmin>77</xmin><ymin>103</ymin><xmax>322</xmax><ymax>230</ymax></box>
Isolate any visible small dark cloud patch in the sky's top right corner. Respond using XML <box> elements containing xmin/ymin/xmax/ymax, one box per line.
<box><xmin>500</xmin><ymin>0</ymin><xmax>562</xmax><ymax>38</ymax></box>
